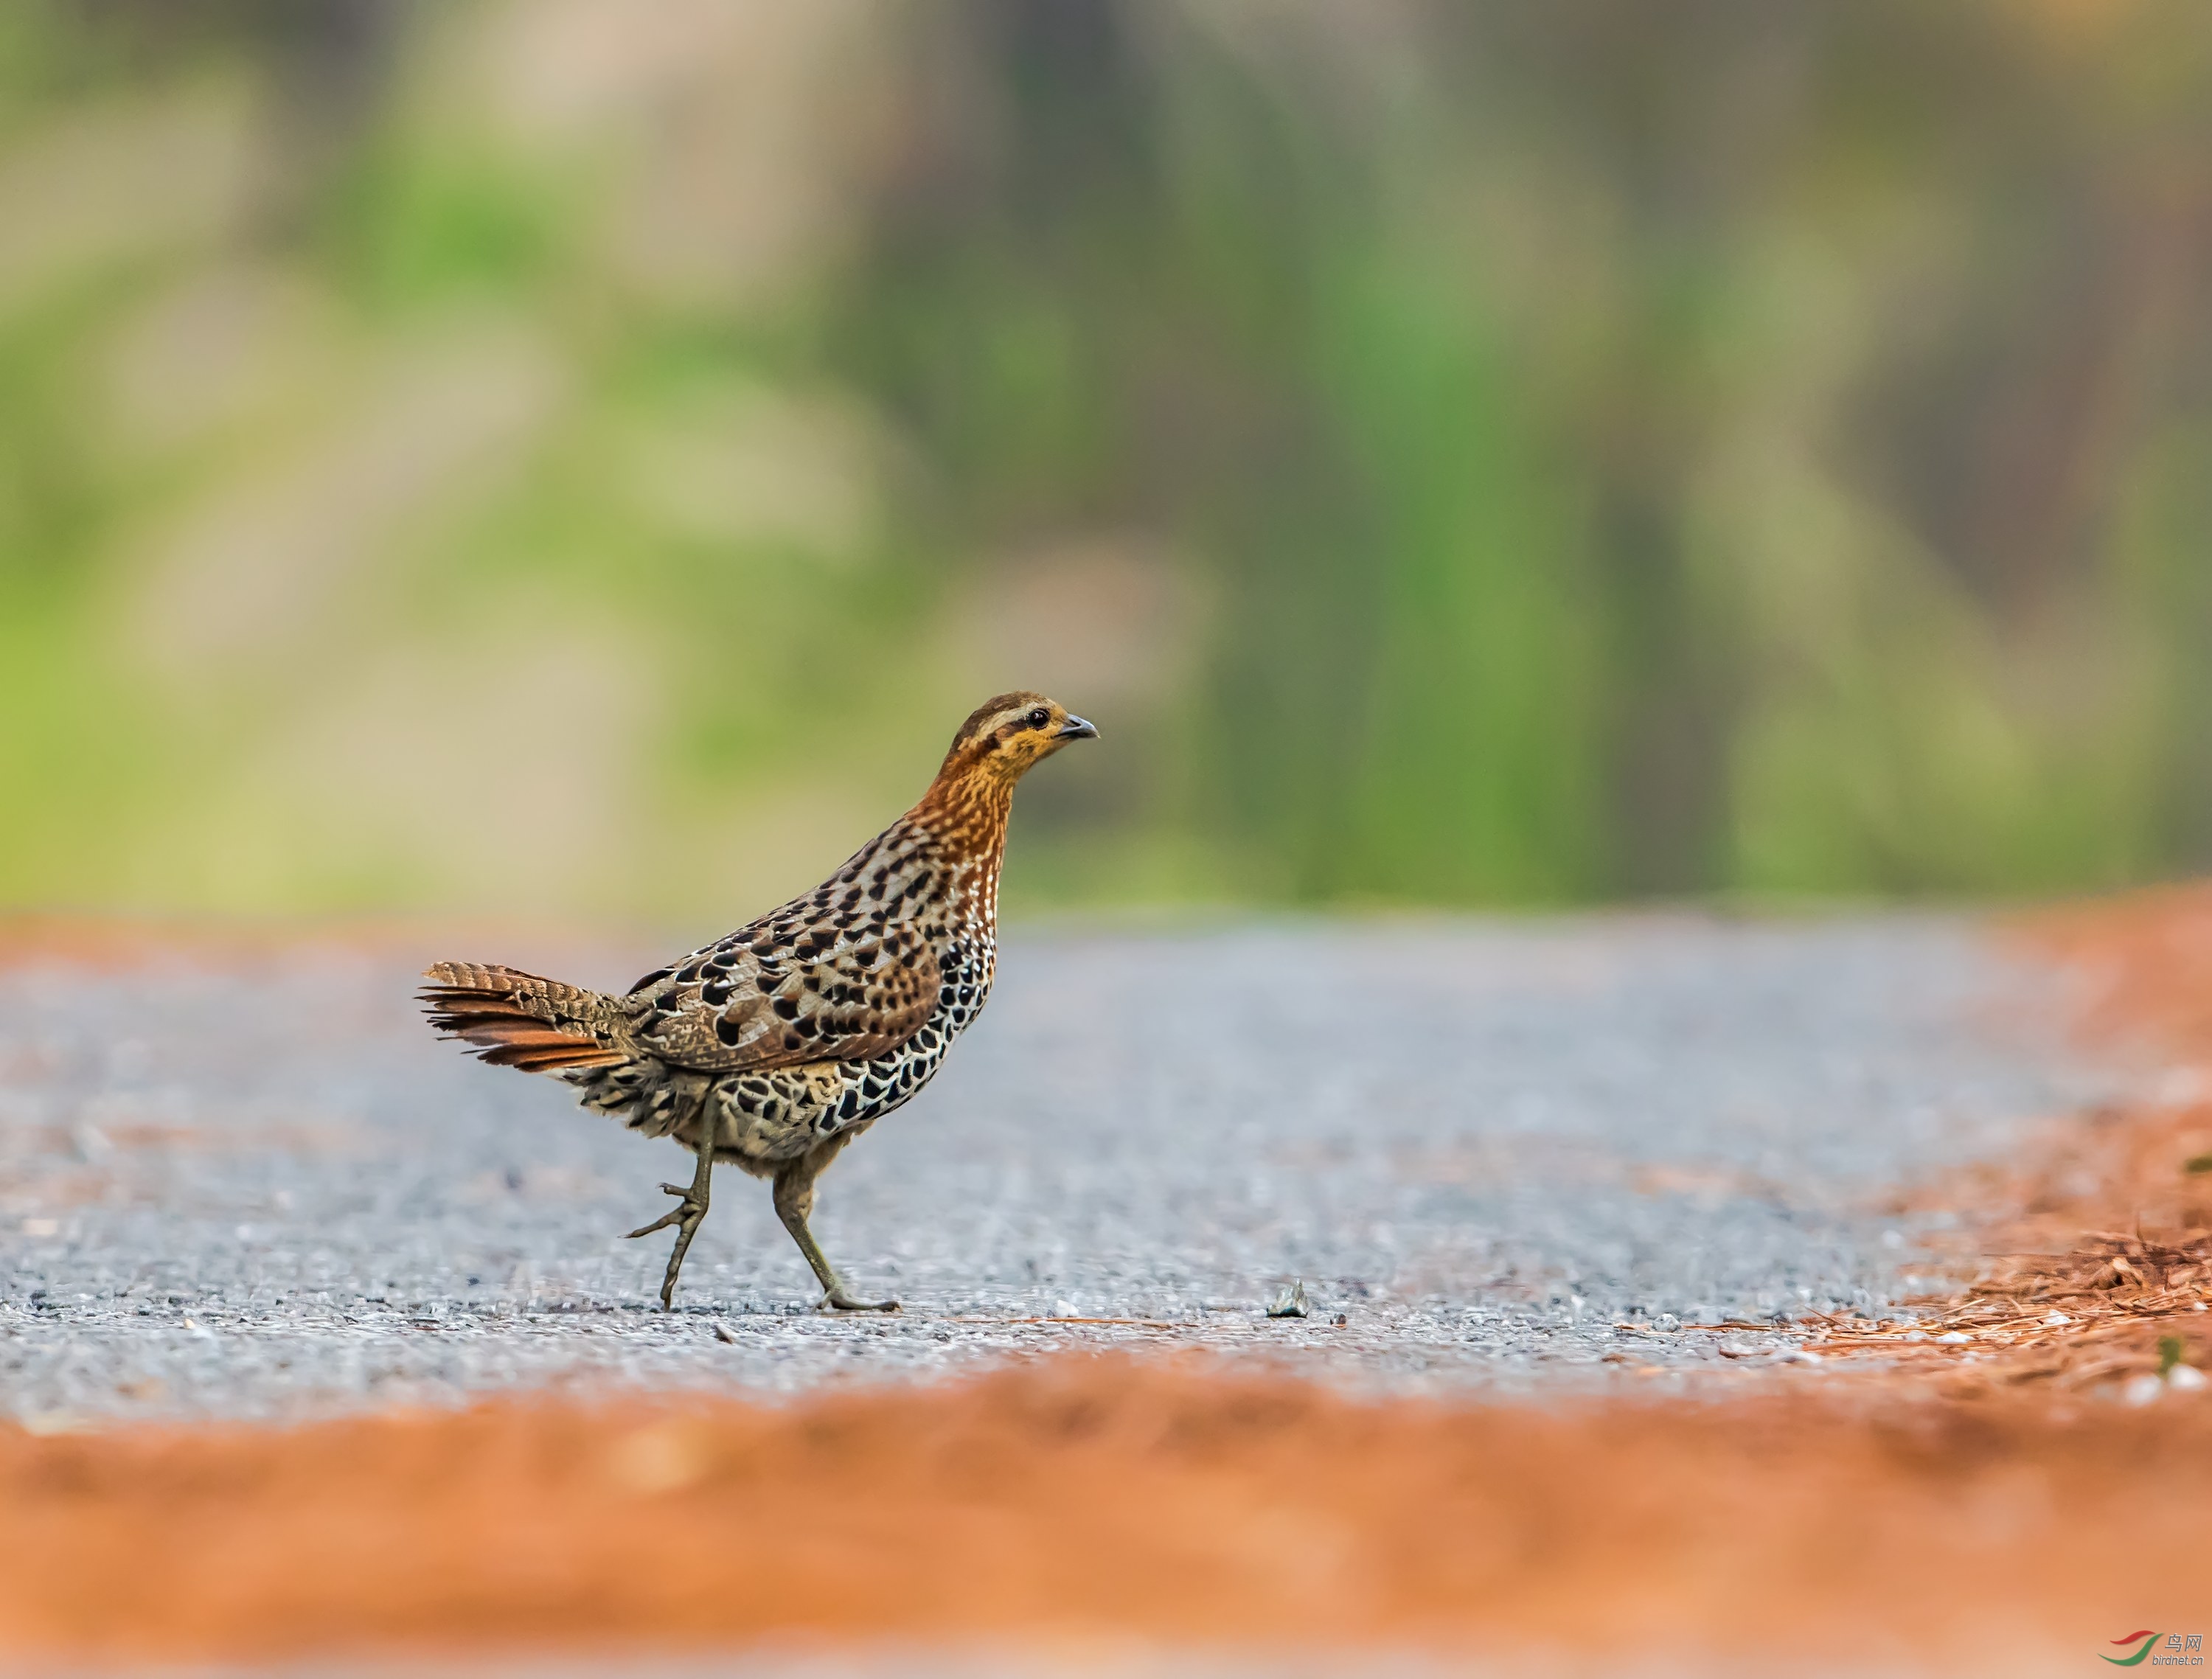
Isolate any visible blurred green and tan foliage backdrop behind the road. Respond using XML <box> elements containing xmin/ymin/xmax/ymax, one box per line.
<box><xmin>0</xmin><ymin>0</ymin><xmax>2212</xmax><ymax>916</ymax></box>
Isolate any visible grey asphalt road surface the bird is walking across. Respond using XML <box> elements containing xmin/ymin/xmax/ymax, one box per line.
<box><xmin>0</xmin><ymin>916</ymin><xmax>2119</xmax><ymax>1427</ymax></box>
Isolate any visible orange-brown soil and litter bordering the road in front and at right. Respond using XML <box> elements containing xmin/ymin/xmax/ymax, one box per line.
<box><xmin>0</xmin><ymin>891</ymin><xmax>2212</xmax><ymax>1670</ymax></box>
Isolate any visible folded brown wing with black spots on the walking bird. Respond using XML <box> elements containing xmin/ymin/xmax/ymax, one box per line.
<box><xmin>624</xmin><ymin>918</ymin><xmax>938</xmax><ymax>1073</ymax></box>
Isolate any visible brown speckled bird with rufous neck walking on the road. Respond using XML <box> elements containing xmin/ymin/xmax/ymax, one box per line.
<box><xmin>418</xmin><ymin>690</ymin><xmax>1097</xmax><ymax>1312</ymax></box>
